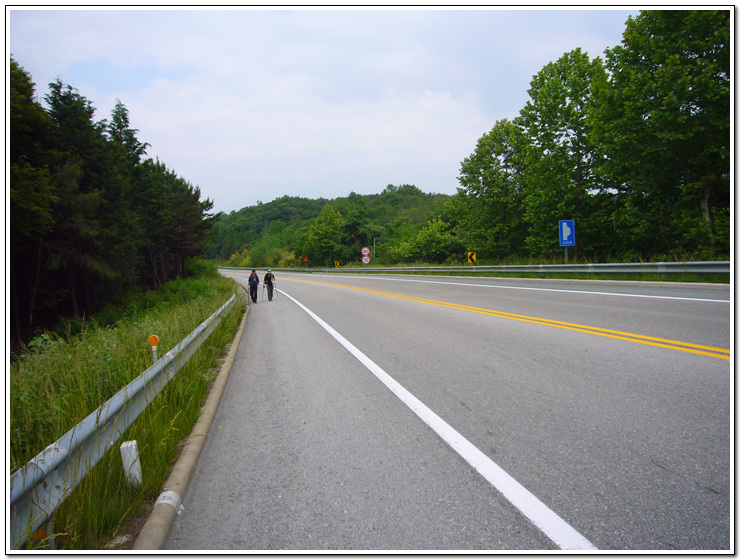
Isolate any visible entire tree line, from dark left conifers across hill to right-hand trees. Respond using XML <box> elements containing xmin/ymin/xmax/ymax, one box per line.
<box><xmin>9</xmin><ymin>10</ymin><xmax>731</xmax><ymax>342</ymax></box>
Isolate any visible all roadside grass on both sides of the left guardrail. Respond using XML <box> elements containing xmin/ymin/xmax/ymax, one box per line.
<box><xmin>9</xmin><ymin>267</ymin><xmax>246</xmax><ymax>550</ymax></box>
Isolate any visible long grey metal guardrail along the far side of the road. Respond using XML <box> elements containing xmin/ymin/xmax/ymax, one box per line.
<box><xmin>219</xmin><ymin>261</ymin><xmax>731</xmax><ymax>275</ymax></box>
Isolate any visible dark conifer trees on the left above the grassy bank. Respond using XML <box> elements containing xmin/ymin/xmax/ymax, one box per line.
<box><xmin>9</xmin><ymin>57</ymin><xmax>213</xmax><ymax>346</ymax></box>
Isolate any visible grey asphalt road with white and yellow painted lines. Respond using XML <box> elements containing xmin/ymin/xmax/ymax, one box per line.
<box><xmin>166</xmin><ymin>271</ymin><xmax>734</xmax><ymax>551</ymax></box>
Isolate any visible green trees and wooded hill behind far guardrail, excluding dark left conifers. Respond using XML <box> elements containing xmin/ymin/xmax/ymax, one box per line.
<box><xmin>209</xmin><ymin>10</ymin><xmax>731</xmax><ymax>266</ymax></box>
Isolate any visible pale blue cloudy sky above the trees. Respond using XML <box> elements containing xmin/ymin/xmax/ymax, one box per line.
<box><xmin>6</xmin><ymin>7</ymin><xmax>638</xmax><ymax>213</ymax></box>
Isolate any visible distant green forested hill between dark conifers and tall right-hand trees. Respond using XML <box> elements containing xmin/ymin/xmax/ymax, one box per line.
<box><xmin>206</xmin><ymin>185</ymin><xmax>450</xmax><ymax>267</ymax></box>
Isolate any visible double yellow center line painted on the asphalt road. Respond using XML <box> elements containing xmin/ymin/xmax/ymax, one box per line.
<box><xmin>282</xmin><ymin>278</ymin><xmax>730</xmax><ymax>360</ymax></box>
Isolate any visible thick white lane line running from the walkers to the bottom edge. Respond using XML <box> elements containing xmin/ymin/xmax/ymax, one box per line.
<box><xmin>279</xmin><ymin>290</ymin><xmax>597</xmax><ymax>550</ymax></box>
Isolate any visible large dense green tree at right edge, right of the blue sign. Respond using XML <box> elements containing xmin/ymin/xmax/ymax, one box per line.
<box><xmin>593</xmin><ymin>10</ymin><xmax>731</xmax><ymax>256</ymax></box>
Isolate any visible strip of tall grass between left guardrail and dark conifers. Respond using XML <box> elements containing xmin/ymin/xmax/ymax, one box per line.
<box><xmin>10</xmin><ymin>276</ymin><xmax>237</xmax><ymax>466</ymax></box>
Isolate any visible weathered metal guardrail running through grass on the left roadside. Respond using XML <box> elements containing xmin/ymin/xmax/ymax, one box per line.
<box><xmin>10</xmin><ymin>295</ymin><xmax>236</xmax><ymax>549</ymax></box>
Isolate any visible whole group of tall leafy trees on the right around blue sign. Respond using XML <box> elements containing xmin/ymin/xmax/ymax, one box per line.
<box><xmin>454</xmin><ymin>10</ymin><xmax>730</xmax><ymax>261</ymax></box>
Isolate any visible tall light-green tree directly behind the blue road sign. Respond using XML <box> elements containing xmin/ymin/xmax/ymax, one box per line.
<box><xmin>517</xmin><ymin>49</ymin><xmax>620</xmax><ymax>256</ymax></box>
